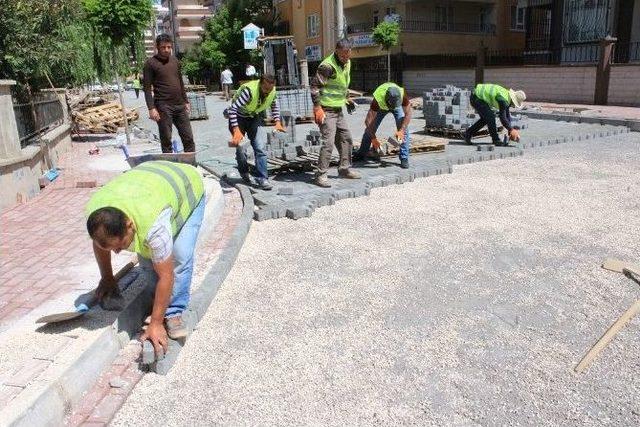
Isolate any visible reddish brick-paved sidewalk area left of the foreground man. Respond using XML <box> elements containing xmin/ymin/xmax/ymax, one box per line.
<box><xmin>0</xmin><ymin>143</ymin><xmax>128</xmax><ymax>331</ymax></box>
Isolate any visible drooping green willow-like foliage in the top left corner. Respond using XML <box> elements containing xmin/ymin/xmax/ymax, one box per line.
<box><xmin>0</xmin><ymin>0</ymin><xmax>144</xmax><ymax>89</ymax></box>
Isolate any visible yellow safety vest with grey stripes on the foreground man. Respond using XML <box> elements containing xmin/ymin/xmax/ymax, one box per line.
<box><xmin>85</xmin><ymin>160</ymin><xmax>204</xmax><ymax>258</ymax></box>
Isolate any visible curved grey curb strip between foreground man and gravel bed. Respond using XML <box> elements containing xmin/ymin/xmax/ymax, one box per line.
<box><xmin>149</xmin><ymin>172</ymin><xmax>253</xmax><ymax>375</ymax></box>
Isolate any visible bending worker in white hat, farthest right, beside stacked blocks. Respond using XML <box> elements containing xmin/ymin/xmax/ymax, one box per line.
<box><xmin>464</xmin><ymin>83</ymin><xmax>527</xmax><ymax>145</ymax></box>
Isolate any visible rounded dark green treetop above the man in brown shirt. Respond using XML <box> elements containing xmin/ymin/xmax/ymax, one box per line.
<box><xmin>84</xmin><ymin>0</ymin><xmax>153</xmax><ymax>46</ymax></box>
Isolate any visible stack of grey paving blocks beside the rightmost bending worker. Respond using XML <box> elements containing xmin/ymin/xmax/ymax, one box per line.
<box><xmin>422</xmin><ymin>85</ymin><xmax>527</xmax><ymax>132</ymax></box>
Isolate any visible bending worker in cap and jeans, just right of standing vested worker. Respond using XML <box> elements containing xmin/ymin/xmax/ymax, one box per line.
<box><xmin>353</xmin><ymin>82</ymin><xmax>411</xmax><ymax>169</ymax></box>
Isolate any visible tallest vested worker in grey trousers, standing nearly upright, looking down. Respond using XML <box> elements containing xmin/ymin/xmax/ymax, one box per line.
<box><xmin>311</xmin><ymin>39</ymin><xmax>361</xmax><ymax>187</ymax></box>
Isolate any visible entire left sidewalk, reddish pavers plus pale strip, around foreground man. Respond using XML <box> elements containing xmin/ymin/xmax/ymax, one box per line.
<box><xmin>0</xmin><ymin>135</ymin><xmax>242</xmax><ymax>424</ymax></box>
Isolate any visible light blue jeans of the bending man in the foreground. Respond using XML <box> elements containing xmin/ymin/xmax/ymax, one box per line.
<box><xmin>139</xmin><ymin>196</ymin><xmax>206</xmax><ymax>317</ymax></box>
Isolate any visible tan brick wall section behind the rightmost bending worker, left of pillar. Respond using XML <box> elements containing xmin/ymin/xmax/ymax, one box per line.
<box><xmin>484</xmin><ymin>66</ymin><xmax>596</xmax><ymax>104</ymax></box>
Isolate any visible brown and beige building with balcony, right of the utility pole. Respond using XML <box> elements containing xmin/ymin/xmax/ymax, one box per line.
<box><xmin>344</xmin><ymin>0</ymin><xmax>524</xmax><ymax>58</ymax></box>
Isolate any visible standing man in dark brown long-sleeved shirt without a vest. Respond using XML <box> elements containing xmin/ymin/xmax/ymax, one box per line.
<box><xmin>143</xmin><ymin>34</ymin><xmax>195</xmax><ymax>153</ymax></box>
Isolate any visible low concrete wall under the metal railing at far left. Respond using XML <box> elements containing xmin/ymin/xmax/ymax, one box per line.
<box><xmin>0</xmin><ymin>124</ymin><xmax>71</xmax><ymax>211</ymax></box>
